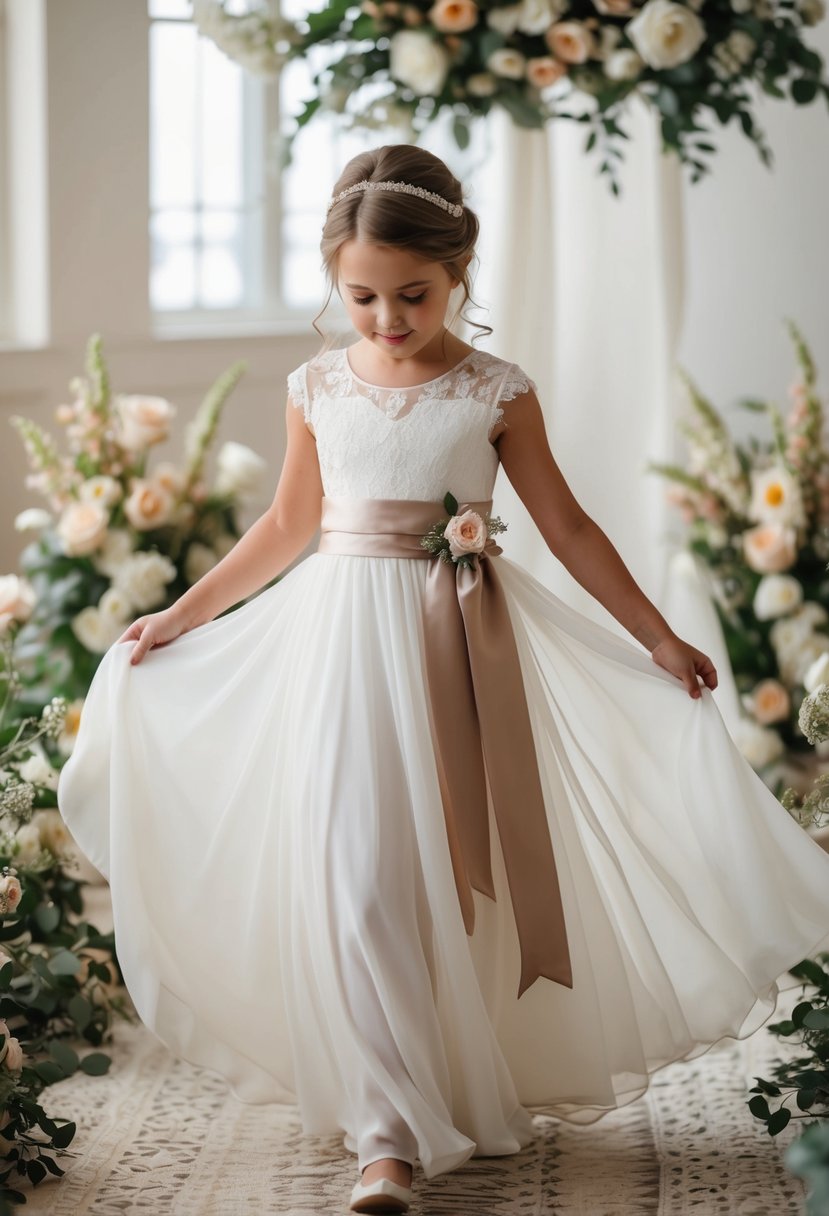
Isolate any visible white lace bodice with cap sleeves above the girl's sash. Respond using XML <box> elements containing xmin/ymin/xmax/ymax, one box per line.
<box><xmin>288</xmin><ymin>347</ymin><xmax>536</xmax><ymax>502</ymax></box>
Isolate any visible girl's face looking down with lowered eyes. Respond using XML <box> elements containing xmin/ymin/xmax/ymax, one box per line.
<box><xmin>337</xmin><ymin>241</ymin><xmax>457</xmax><ymax>359</ymax></box>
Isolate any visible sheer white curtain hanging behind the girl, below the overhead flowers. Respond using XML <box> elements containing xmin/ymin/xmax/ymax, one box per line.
<box><xmin>472</xmin><ymin>102</ymin><xmax>684</xmax><ymax>634</ymax></box>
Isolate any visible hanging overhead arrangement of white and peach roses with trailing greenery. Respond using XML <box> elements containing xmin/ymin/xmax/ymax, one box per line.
<box><xmin>193</xmin><ymin>0</ymin><xmax>829</xmax><ymax>195</ymax></box>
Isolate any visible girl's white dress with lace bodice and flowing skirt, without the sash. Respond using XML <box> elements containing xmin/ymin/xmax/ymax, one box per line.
<box><xmin>58</xmin><ymin>349</ymin><xmax>829</xmax><ymax>1178</ymax></box>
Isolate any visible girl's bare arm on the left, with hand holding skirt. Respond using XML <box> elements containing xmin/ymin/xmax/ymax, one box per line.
<box><xmin>118</xmin><ymin>398</ymin><xmax>323</xmax><ymax>664</ymax></box>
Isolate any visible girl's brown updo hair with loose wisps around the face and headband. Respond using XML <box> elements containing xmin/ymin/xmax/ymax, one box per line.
<box><xmin>311</xmin><ymin>143</ymin><xmax>492</xmax><ymax>349</ymax></box>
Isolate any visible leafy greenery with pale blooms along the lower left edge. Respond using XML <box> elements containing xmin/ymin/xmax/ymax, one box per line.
<box><xmin>0</xmin><ymin>612</ymin><xmax>128</xmax><ymax>1211</ymax></box>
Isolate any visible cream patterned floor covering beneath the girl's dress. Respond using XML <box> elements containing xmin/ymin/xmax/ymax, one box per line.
<box><xmin>24</xmin><ymin>893</ymin><xmax>803</xmax><ymax>1216</ymax></box>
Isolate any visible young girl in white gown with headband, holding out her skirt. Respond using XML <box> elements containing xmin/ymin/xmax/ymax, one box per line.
<box><xmin>58</xmin><ymin>145</ymin><xmax>829</xmax><ymax>1212</ymax></box>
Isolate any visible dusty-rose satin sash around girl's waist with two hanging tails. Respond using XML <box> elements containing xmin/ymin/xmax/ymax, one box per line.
<box><xmin>317</xmin><ymin>497</ymin><xmax>573</xmax><ymax>997</ymax></box>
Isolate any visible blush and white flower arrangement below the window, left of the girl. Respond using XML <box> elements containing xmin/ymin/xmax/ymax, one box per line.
<box><xmin>8</xmin><ymin>334</ymin><xmax>266</xmax><ymax>710</ymax></box>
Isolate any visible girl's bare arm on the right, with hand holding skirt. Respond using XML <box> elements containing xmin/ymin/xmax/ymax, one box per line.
<box><xmin>495</xmin><ymin>389</ymin><xmax>717</xmax><ymax>697</ymax></box>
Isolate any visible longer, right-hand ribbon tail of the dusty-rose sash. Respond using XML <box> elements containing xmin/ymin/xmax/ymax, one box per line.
<box><xmin>457</xmin><ymin>554</ymin><xmax>573</xmax><ymax>997</ymax></box>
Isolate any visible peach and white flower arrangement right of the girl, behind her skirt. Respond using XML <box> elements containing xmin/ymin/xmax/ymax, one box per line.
<box><xmin>650</xmin><ymin>321</ymin><xmax>829</xmax><ymax>770</ymax></box>
